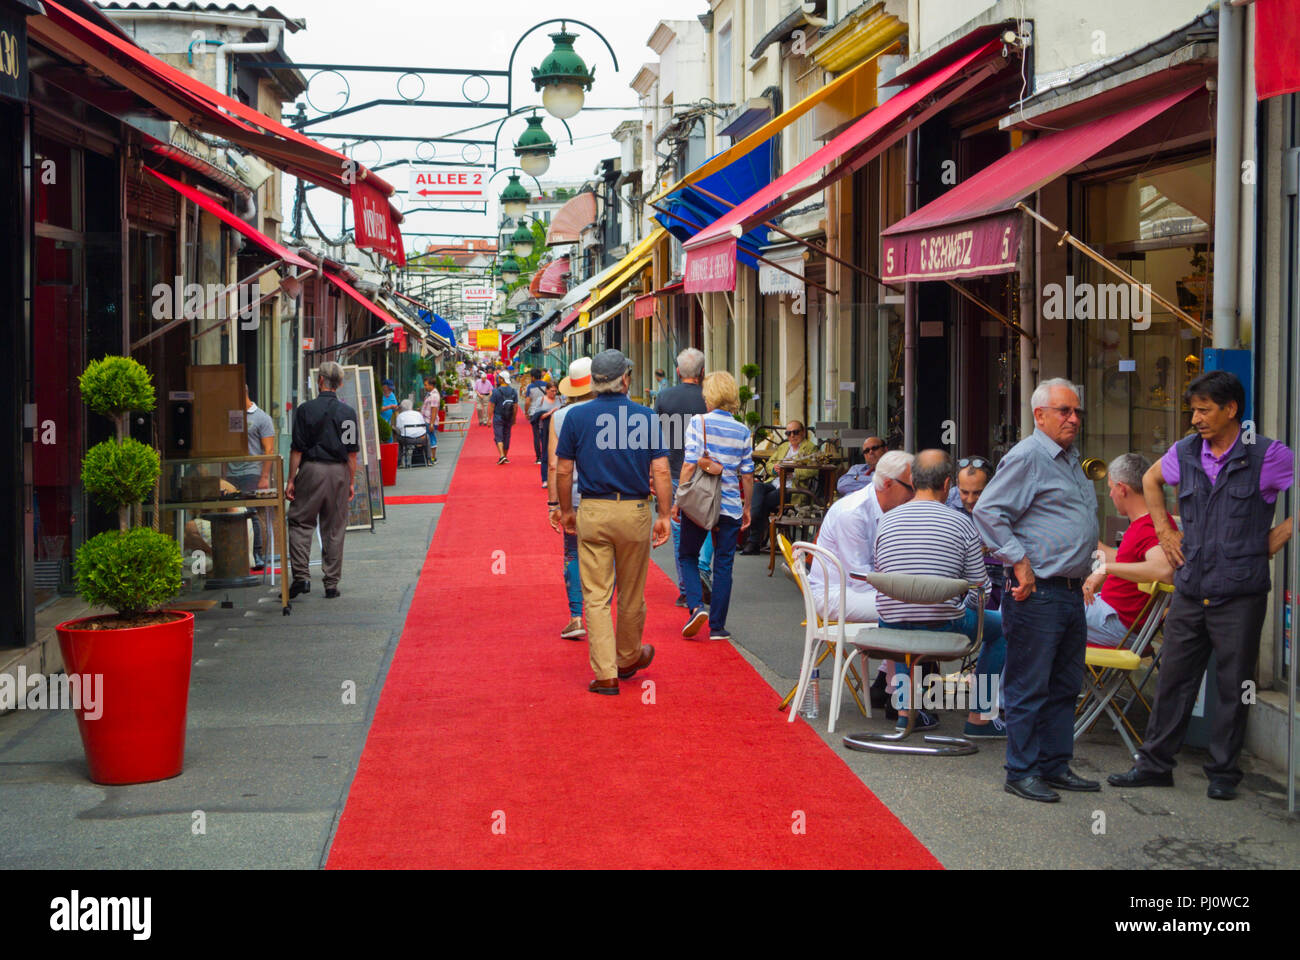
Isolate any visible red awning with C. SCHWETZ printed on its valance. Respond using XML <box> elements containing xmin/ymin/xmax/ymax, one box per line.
<box><xmin>880</xmin><ymin>81</ymin><xmax>1203</xmax><ymax>281</ymax></box>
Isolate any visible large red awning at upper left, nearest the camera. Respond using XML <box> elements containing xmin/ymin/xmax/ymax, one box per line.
<box><xmin>27</xmin><ymin>0</ymin><xmax>402</xmax><ymax>261</ymax></box>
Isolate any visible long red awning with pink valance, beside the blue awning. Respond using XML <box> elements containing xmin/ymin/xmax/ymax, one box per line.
<box><xmin>685</xmin><ymin>42</ymin><xmax>1006</xmax><ymax>293</ymax></box>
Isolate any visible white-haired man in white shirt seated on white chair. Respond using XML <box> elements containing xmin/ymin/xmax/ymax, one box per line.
<box><xmin>809</xmin><ymin>450</ymin><xmax>915</xmax><ymax>623</ymax></box>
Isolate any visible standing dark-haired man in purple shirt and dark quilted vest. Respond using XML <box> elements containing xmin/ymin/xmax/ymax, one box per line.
<box><xmin>1108</xmin><ymin>371</ymin><xmax>1294</xmax><ymax>800</ymax></box>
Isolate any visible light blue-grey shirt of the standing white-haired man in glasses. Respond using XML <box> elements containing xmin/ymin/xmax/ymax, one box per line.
<box><xmin>971</xmin><ymin>428</ymin><xmax>1097</xmax><ymax>579</ymax></box>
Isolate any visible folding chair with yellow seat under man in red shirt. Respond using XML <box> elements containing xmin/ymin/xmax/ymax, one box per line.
<box><xmin>1074</xmin><ymin>574</ymin><xmax>1174</xmax><ymax>754</ymax></box>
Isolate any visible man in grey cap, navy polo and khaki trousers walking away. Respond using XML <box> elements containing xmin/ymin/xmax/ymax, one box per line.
<box><xmin>555</xmin><ymin>350</ymin><xmax>672</xmax><ymax>695</ymax></box>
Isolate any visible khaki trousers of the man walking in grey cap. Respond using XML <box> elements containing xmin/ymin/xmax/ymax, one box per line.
<box><xmin>577</xmin><ymin>497</ymin><xmax>654</xmax><ymax>680</ymax></box>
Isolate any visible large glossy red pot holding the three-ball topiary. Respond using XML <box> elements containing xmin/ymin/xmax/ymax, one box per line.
<box><xmin>55</xmin><ymin>610</ymin><xmax>194</xmax><ymax>783</ymax></box>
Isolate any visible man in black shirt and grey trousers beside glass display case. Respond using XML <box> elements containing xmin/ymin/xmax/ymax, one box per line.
<box><xmin>285</xmin><ymin>360</ymin><xmax>360</xmax><ymax>600</ymax></box>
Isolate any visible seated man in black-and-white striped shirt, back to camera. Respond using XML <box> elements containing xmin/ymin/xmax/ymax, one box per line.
<box><xmin>875</xmin><ymin>450</ymin><xmax>1006</xmax><ymax>739</ymax></box>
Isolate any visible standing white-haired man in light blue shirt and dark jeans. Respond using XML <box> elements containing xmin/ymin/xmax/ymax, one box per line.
<box><xmin>972</xmin><ymin>377</ymin><xmax>1101</xmax><ymax>803</ymax></box>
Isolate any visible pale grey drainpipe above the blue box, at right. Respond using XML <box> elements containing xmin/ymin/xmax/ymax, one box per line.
<box><xmin>1213</xmin><ymin>3</ymin><xmax>1255</xmax><ymax>349</ymax></box>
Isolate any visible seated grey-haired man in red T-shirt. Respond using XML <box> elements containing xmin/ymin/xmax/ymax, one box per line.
<box><xmin>1083</xmin><ymin>453</ymin><xmax>1174</xmax><ymax>647</ymax></box>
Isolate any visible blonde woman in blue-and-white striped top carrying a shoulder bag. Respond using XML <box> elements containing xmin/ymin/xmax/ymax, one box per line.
<box><xmin>672</xmin><ymin>371</ymin><xmax>754</xmax><ymax>640</ymax></box>
